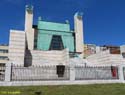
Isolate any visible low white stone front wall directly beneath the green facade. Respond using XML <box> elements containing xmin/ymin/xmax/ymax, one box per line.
<box><xmin>27</xmin><ymin>49</ymin><xmax>69</xmax><ymax>66</ymax></box>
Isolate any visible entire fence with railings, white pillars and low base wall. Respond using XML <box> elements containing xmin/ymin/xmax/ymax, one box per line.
<box><xmin>0</xmin><ymin>64</ymin><xmax>125</xmax><ymax>86</ymax></box>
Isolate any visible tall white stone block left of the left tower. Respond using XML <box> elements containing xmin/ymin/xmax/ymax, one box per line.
<box><xmin>9</xmin><ymin>30</ymin><xmax>25</xmax><ymax>66</ymax></box>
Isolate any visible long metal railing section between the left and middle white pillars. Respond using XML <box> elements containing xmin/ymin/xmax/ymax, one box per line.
<box><xmin>11</xmin><ymin>65</ymin><xmax>70</xmax><ymax>81</ymax></box>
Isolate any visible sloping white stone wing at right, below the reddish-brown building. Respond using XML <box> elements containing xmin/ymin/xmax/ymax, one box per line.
<box><xmin>86</xmin><ymin>50</ymin><xmax>125</xmax><ymax>65</ymax></box>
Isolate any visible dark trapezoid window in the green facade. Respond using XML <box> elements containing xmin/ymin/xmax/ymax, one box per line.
<box><xmin>50</xmin><ymin>35</ymin><xmax>64</xmax><ymax>50</ymax></box>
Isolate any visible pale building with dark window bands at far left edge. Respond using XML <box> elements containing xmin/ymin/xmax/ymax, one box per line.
<box><xmin>0</xmin><ymin>44</ymin><xmax>8</xmax><ymax>65</ymax></box>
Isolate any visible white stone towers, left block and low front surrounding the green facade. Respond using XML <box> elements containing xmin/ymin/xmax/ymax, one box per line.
<box><xmin>9</xmin><ymin>6</ymin><xmax>83</xmax><ymax>66</ymax></box>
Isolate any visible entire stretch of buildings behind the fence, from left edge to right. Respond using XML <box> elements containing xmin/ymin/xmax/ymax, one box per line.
<box><xmin>0</xmin><ymin>5</ymin><xmax>125</xmax><ymax>67</ymax></box>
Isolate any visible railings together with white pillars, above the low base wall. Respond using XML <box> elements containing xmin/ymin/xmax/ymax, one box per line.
<box><xmin>0</xmin><ymin>64</ymin><xmax>125</xmax><ymax>82</ymax></box>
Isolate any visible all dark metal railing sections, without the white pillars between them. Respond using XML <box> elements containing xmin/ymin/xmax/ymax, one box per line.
<box><xmin>0</xmin><ymin>65</ymin><xmax>119</xmax><ymax>81</ymax></box>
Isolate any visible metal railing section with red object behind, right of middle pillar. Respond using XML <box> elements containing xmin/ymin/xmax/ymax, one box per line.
<box><xmin>75</xmin><ymin>66</ymin><xmax>119</xmax><ymax>80</ymax></box>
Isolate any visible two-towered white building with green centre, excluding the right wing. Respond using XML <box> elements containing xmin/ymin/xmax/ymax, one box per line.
<box><xmin>9</xmin><ymin>5</ymin><xmax>83</xmax><ymax>66</ymax></box>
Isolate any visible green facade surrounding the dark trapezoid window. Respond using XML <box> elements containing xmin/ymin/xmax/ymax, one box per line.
<box><xmin>37</xmin><ymin>21</ymin><xmax>75</xmax><ymax>52</ymax></box>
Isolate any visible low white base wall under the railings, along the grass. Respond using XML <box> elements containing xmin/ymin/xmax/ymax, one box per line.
<box><xmin>0</xmin><ymin>80</ymin><xmax>121</xmax><ymax>86</ymax></box>
